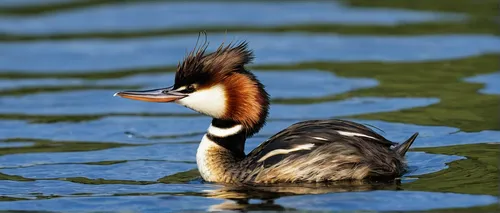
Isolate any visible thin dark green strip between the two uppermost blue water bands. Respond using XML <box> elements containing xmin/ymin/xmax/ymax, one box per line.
<box><xmin>0</xmin><ymin>20</ymin><xmax>499</xmax><ymax>42</ymax></box>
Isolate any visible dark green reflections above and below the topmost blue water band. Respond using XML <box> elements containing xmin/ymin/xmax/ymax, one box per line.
<box><xmin>0</xmin><ymin>0</ymin><xmax>500</xmax><ymax>41</ymax></box>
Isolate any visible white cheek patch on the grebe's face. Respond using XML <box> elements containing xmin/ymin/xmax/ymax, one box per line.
<box><xmin>177</xmin><ymin>84</ymin><xmax>226</xmax><ymax>118</ymax></box>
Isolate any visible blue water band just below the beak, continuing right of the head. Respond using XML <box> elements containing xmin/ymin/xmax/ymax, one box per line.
<box><xmin>0</xmin><ymin>93</ymin><xmax>439</xmax><ymax>118</ymax></box>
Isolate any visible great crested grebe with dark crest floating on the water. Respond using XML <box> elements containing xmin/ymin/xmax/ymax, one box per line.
<box><xmin>115</xmin><ymin>42</ymin><xmax>418</xmax><ymax>184</ymax></box>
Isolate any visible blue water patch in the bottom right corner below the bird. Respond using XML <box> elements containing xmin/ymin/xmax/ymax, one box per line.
<box><xmin>278</xmin><ymin>191</ymin><xmax>498</xmax><ymax>211</ymax></box>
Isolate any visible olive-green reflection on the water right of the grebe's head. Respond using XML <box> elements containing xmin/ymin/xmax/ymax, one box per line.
<box><xmin>258</xmin><ymin>54</ymin><xmax>500</xmax><ymax>131</ymax></box>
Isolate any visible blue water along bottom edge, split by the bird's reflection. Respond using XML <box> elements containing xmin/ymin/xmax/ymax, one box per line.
<box><xmin>0</xmin><ymin>191</ymin><xmax>496</xmax><ymax>212</ymax></box>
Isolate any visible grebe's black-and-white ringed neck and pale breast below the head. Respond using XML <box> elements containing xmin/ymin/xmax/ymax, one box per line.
<box><xmin>196</xmin><ymin>118</ymin><xmax>247</xmax><ymax>182</ymax></box>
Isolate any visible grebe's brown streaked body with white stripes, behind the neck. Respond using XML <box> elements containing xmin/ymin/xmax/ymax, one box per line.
<box><xmin>239</xmin><ymin>119</ymin><xmax>414</xmax><ymax>183</ymax></box>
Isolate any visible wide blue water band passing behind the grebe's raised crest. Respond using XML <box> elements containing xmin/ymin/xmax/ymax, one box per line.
<box><xmin>0</xmin><ymin>33</ymin><xmax>500</xmax><ymax>73</ymax></box>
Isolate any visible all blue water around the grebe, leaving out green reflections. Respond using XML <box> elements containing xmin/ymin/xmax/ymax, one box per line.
<box><xmin>0</xmin><ymin>0</ymin><xmax>500</xmax><ymax>212</ymax></box>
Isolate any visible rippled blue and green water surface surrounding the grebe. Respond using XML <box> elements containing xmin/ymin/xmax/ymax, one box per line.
<box><xmin>0</xmin><ymin>0</ymin><xmax>500</xmax><ymax>212</ymax></box>
